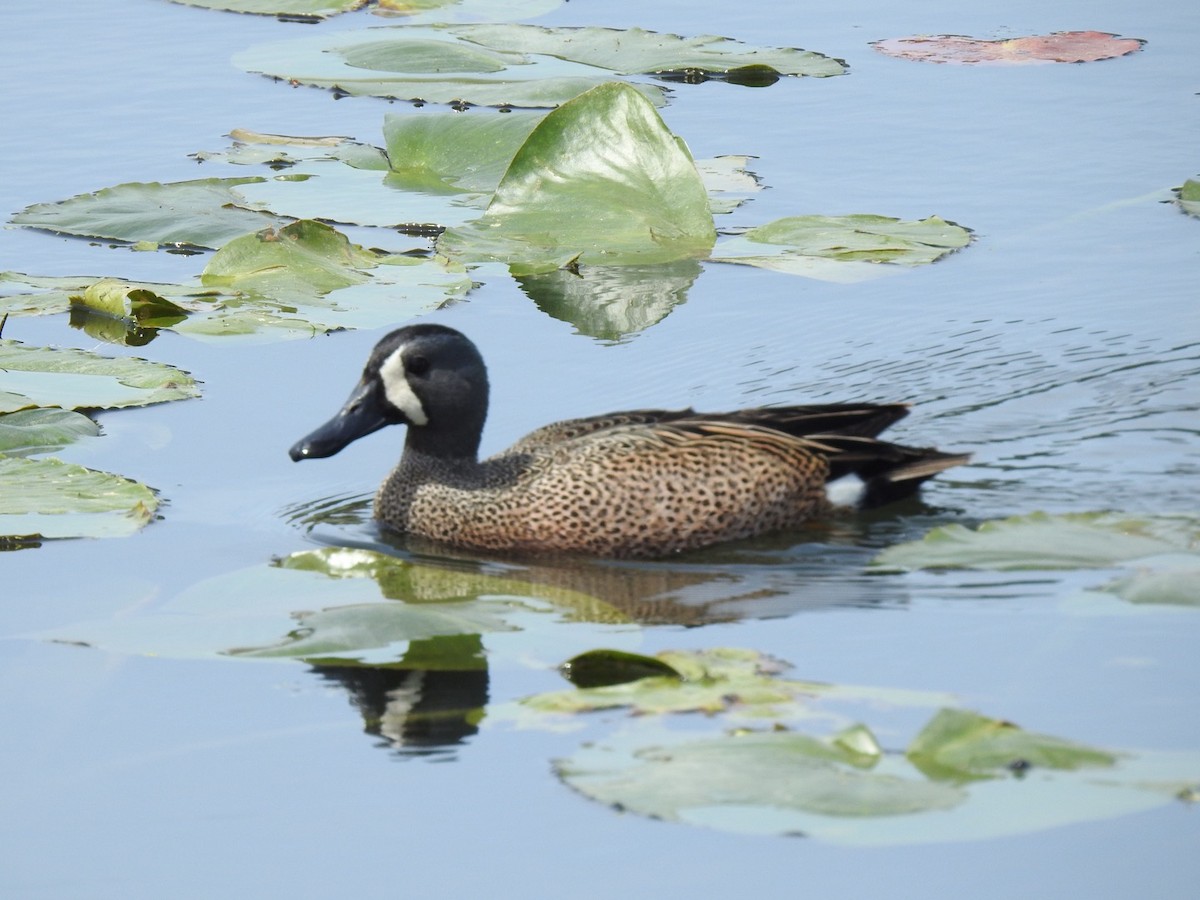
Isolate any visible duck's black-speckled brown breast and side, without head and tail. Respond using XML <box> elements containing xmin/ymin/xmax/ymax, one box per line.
<box><xmin>376</xmin><ymin>420</ymin><xmax>828</xmax><ymax>557</ymax></box>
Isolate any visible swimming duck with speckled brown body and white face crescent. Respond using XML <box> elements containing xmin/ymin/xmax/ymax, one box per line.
<box><xmin>289</xmin><ymin>323</ymin><xmax>970</xmax><ymax>558</ymax></box>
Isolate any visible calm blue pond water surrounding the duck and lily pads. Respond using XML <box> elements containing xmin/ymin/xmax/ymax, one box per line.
<box><xmin>0</xmin><ymin>0</ymin><xmax>1200</xmax><ymax>898</ymax></box>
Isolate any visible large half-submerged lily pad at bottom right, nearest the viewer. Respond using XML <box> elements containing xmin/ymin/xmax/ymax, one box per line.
<box><xmin>554</xmin><ymin>710</ymin><xmax>1200</xmax><ymax>845</ymax></box>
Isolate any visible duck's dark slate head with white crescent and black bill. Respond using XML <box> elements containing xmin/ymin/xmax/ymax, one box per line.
<box><xmin>289</xmin><ymin>325</ymin><xmax>487</xmax><ymax>462</ymax></box>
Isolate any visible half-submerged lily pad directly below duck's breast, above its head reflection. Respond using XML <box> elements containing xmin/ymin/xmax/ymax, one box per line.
<box><xmin>37</xmin><ymin>547</ymin><xmax>624</xmax><ymax>667</ymax></box>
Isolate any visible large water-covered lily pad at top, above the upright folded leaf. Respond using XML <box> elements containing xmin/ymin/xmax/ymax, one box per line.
<box><xmin>234</xmin><ymin>24</ymin><xmax>845</xmax><ymax>107</ymax></box>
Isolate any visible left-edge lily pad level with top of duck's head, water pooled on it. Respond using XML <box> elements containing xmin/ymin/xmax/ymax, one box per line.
<box><xmin>0</xmin><ymin>340</ymin><xmax>200</xmax><ymax>413</ymax></box>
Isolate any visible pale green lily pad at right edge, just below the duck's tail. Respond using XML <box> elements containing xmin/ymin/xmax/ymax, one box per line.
<box><xmin>872</xmin><ymin>512</ymin><xmax>1200</xmax><ymax>570</ymax></box>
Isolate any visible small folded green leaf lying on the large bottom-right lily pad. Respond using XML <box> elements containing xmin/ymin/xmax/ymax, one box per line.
<box><xmin>907</xmin><ymin>709</ymin><xmax>1117</xmax><ymax>780</ymax></box>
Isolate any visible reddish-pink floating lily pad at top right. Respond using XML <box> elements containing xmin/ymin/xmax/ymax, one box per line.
<box><xmin>871</xmin><ymin>31</ymin><xmax>1146</xmax><ymax>66</ymax></box>
